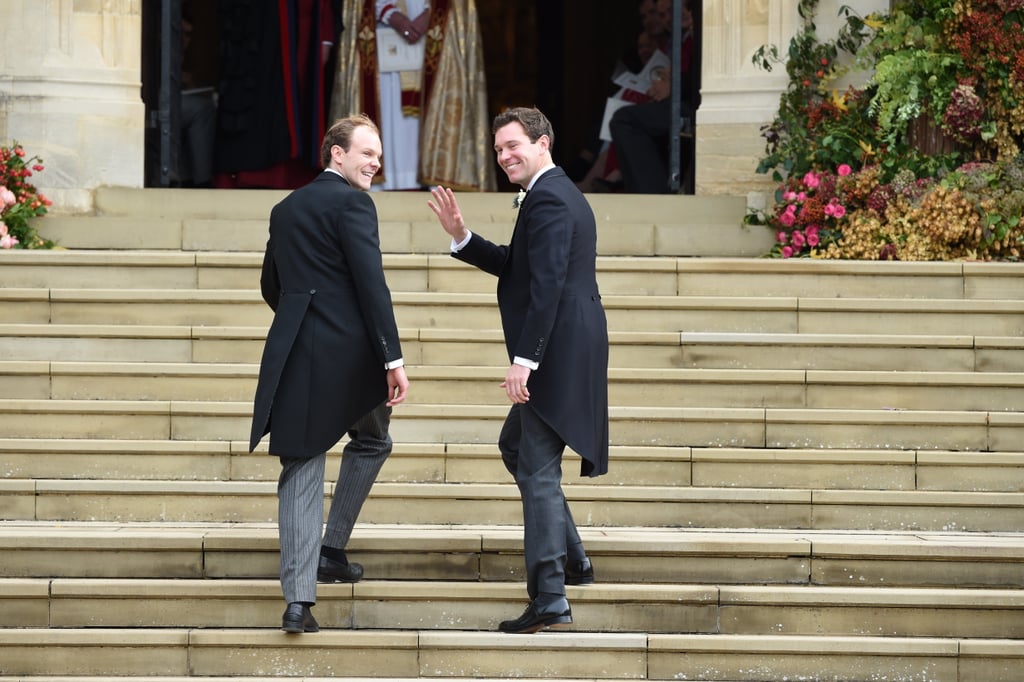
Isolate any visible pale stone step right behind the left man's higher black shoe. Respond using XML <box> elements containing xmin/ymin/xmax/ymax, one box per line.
<box><xmin>0</xmin><ymin>521</ymin><xmax>1024</xmax><ymax>590</ymax></box>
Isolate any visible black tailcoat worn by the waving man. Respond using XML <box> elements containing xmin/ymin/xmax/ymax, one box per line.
<box><xmin>453</xmin><ymin>168</ymin><xmax>608</xmax><ymax>476</ymax></box>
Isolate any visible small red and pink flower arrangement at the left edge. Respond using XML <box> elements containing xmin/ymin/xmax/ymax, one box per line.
<box><xmin>0</xmin><ymin>142</ymin><xmax>56</xmax><ymax>249</ymax></box>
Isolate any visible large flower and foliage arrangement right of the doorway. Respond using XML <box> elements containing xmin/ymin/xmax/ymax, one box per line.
<box><xmin>745</xmin><ymin>0</ymin><xmax>1024</xmax><ymax>260</ymax></box>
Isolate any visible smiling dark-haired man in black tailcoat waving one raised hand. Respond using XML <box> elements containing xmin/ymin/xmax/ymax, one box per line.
<box><xmin>428</xmin><ymin>108</ymin><xmax>608</xmax><ymax>633</ymax></box>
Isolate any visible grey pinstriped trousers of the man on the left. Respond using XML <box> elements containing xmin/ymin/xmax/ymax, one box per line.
<box><xmin>278</xmin><ymin>403</ymin><xmax>391</xmax><ymax>603</ymax></box>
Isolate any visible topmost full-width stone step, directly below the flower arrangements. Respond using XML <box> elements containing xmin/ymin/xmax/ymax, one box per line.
<box><xmin>8</xmin><ymin>249</ymin><xmax>1024</xmax><ymax>300</ymax></box>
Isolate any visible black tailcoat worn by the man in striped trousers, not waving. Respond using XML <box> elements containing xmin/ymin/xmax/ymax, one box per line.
<box><xmin>249</xmin><ymin>171</ymin><xmax>401</xmax><ymax>457</ymax></box>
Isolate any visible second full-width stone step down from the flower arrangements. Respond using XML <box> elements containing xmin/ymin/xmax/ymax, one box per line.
<box><xmin>8</xmin><ymin>288</ymin><xmax>1024</xmax><ymax>337</ymax></box>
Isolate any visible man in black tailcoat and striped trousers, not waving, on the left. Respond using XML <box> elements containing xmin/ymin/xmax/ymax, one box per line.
<box><xmin>249</xmin><ymin>116</ymin><xmax>409</xmax><ymax>633</ymax></box>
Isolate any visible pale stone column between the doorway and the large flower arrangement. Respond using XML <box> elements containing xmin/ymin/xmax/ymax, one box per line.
<box><xmin>696</xmin><ymin>0</ymin><xmax>889</xmax><ymax>199</ymax></box>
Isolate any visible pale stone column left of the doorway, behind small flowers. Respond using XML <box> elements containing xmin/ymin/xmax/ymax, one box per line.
<box><xmin>0</xmin><ymin>0</ymin><xmax>145</xmax><ymax>212</ymax></box>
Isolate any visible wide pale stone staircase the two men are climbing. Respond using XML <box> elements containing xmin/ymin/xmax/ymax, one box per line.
<box><xmin>0</xmin><ymin>188</ymin><xmax>1024</xmax><ymax>682</ymax></box>
